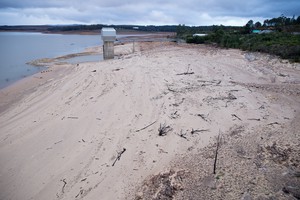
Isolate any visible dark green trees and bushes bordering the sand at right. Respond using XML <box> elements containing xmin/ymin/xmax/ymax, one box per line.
<box><xmin>182</xmin><ymin>16</ymin><xmax>300</xmax><ymax>62</ymax></box>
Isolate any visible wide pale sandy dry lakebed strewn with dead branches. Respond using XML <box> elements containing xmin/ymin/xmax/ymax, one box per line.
<box><xmin>0</xmin><ymin>42</ymin><xmax>300</xmax><ymax>200</ymax></box>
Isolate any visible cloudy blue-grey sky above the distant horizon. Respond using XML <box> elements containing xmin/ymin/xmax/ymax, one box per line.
<box><xmin>0</xmin><ymin>0</ymin><xmax>300</xmax><ymax>25</ymax></box>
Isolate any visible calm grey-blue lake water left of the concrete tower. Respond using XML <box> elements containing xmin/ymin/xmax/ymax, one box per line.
<box><xmin>0</xmin><ymin>32</ymin><xmax>102</xmax><ymax>88</ymax></box>
